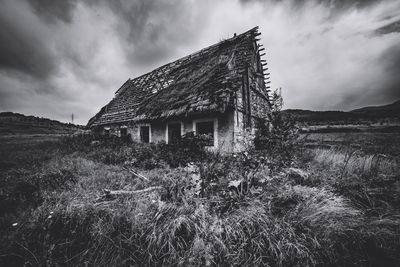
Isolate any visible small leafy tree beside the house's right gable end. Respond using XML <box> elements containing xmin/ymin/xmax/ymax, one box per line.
<box><xmin>254</xmin><ymin>89</ymin><xmax>298</xmax><ymax>166</ymax></box>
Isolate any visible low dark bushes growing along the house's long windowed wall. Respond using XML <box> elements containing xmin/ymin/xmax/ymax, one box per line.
<box><xmin>61</xmin><ymin>133</ymin><xmax>209</xmax><ymax>170</ymax></box>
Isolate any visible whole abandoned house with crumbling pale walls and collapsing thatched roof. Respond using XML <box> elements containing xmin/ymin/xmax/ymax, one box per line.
<box><xmin>88</xmin><ymin>27</ymin><xmax>270</xmax><ymax>152</ymax></box>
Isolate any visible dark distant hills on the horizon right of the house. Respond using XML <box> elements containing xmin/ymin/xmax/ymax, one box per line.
<box><xmin>283</xmin><ymin>100</ymin><xmax>400</xmax><ymax>125</ymax></box>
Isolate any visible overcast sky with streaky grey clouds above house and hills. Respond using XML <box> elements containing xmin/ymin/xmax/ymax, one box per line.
<box><xmin>0</xmin><ymin>0</ymin><xmax>400</xmax><ymax>124</ymax></box>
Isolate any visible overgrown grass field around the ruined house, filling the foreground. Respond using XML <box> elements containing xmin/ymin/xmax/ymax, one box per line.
<box><xmin>0</xmin><ymin>133</ymin><xmax>400</xmax><ymax>266</ymax></box>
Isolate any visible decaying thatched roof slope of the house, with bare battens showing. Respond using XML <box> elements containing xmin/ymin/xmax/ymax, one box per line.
<box><xmin>88</xmin><ymin>27</ymin><xmax>266</xmax><ymax>126</ymax></box>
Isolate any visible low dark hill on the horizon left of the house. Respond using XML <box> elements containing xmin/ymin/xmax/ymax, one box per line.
<box><xmin>0</xmin><ymin>112</ymin><xmax>84</xmax><ymax>135</ymax></box>
